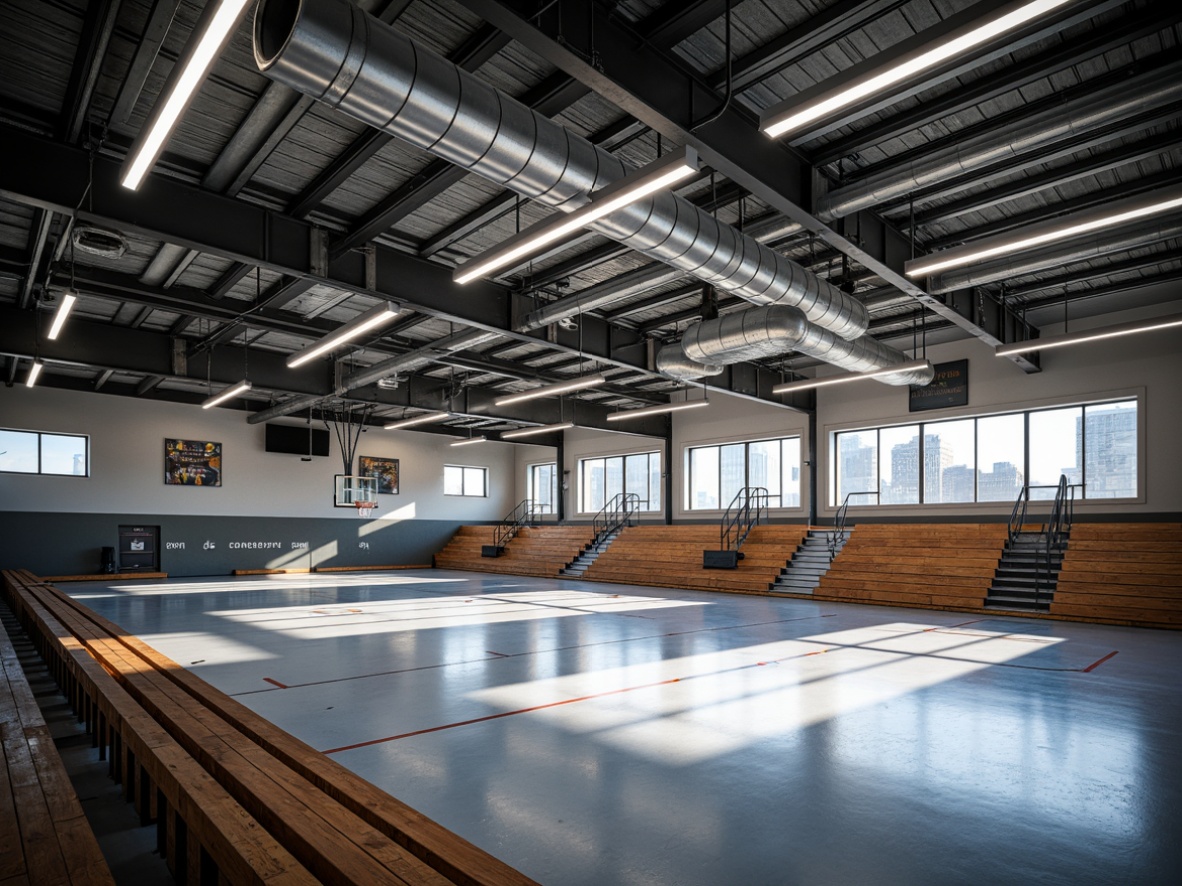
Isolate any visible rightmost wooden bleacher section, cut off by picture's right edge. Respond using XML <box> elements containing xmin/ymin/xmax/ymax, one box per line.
<box><xmin>1051</xmin><ymin>522</ymin><xmax>1182</xmax><ymax>628</ymax></box>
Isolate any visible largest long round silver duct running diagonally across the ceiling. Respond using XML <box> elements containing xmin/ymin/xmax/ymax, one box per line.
<box><xmin>254</xmin><ymin>0</ymin><xmax>869</xmax><ymax>339</ymax></box>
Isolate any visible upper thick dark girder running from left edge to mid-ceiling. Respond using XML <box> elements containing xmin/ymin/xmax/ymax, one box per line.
<box><xmin>0</xmin><ymin>125</ymin><xmax>803</xmax><ymax>413</ymax></box>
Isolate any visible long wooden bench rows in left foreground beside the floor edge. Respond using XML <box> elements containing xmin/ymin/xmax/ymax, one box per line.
<box><xmin>5</xmin><ymin>572</ymin><xmax>533</xmax><ymax>886</ymax></box>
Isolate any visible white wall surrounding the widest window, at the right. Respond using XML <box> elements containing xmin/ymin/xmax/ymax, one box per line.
<box><xmin>817</xmin><ymin>305</ymin><xmax>1182</xmax><ymax>517</ymax></box>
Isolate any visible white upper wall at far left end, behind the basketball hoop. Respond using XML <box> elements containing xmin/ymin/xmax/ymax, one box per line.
<box><xmin>0</xmin><ymin>386</ymin><xmax>515</xmax><ymax>522</ymax></box>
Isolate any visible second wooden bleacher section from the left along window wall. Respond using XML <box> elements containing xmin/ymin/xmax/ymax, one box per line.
<box><xmin>584</xmin><ymin>525</ymin><xmax>808</xmax><ymax>594</ymax></box>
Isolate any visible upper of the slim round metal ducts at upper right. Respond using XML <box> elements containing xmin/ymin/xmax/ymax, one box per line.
<box><xmin>817</xmin><ymin>64</ymin><xmax>1182</xmax><ymax>221</ymax></box>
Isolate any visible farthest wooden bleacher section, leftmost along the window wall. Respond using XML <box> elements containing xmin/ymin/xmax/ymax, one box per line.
<box><xmin>435</xmin><ymin>526</ymin><xmax>595</xmax><ymax>576</ymax></box>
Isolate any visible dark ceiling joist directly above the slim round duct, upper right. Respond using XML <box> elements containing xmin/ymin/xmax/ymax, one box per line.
<box><xmin>810</xmin><ymin>9</ymin><xmax>1178</xmax><ymax>167</ymax></box>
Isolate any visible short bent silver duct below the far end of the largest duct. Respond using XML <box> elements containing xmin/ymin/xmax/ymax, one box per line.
<box><xmin>681</xmin><ymin>305</ymin><xmax>933</xmax><ymax>385</ymax></box>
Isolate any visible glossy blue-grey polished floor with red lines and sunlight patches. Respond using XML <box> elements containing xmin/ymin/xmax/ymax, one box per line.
<box><xmin>65</xmin><ymin>569</ymin><xmax>1182</xmax><ymax>886</ymax></box>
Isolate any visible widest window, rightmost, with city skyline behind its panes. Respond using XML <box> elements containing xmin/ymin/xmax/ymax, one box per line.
<box><xmin>831</xmin><ymin>400</ymin><xmax>1137</xmax><ymax>506</ymax></box>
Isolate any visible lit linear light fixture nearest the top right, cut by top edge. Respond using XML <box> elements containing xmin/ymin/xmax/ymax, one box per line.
<box><xmin>759</xmin><ymin>0</ymin><xmax>1070</xmax><ymax>138</ymax></box>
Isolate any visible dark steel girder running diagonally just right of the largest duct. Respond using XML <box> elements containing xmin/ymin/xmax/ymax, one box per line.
<box><xmin>451</xmin><ymin>0</ymin><xmax>1038</xmax><ymax>372</ymax></box>
